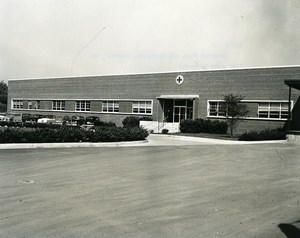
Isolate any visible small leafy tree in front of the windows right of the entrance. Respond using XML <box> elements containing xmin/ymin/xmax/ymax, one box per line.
<box><xmin>223</xmin><ymin>94</ymin><xmax>249</xmax><ymax>137</ymax></box>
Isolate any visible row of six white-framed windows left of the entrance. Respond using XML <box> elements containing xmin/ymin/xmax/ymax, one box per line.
<box><xmin>12</xmin><ymin>100</ymin><xmax>152</xmax><ymax>114</ymax></box>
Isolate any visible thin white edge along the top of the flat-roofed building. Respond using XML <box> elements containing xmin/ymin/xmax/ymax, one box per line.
<box><xmin>8</xmin><ymin>65</ymin><xmax>300</xmax><ymax>81</ymax></box>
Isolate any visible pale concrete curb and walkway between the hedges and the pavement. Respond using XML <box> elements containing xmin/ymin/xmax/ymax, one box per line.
<box><xmin>0</xmin><ymin>134</ymin><xmax>287</xmax><ymax>149</ymax></box>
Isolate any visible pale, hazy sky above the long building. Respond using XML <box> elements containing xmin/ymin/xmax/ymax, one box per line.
<box><xmin>0</xmin><ymin>0</ymin><xmax>300</xmax><ymax>82</ymax></box>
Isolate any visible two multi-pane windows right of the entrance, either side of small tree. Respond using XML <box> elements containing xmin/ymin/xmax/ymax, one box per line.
<box><xmin>208</xmin><ymin>101</ymin><xmax>289</xmax><ymax>119</ymax></box>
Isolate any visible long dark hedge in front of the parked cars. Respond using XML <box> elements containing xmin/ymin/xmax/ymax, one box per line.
<box><xmin>0</xmin><ymin>127</ymin><xmax>148</xmax><ymax>143</ymax></box>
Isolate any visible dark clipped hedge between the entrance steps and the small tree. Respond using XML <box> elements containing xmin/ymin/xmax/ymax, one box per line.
<box><xmin>180</xmin><ymin>118</ymin><xmax>228</xmax><ymax>134</ymax></box>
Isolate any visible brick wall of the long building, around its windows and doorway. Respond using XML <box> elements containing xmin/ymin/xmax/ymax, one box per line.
<box><xmin>8</xmin><ymin>67</ymin><xmax>300</xmax><ymax>130</ymax></box>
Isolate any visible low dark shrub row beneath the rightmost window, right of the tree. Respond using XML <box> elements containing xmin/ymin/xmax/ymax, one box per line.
<box><xmin>239</xmin><ymin>128</ymin><xmax>286</xmax><ymax>141</ymax></box>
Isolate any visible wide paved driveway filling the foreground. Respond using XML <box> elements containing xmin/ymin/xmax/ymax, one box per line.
<box><xmin>0</xmin><ymin>139</ymin><xmax>300</xmax><ymax>238</ymax></box>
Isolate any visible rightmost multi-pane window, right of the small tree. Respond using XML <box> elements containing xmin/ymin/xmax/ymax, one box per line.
<box><xmin>257</xmin><ymin>102</ymin><xmax>289</xmax><ymax>119</ymax></box>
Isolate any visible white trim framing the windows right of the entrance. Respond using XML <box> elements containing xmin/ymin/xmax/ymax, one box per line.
<box><xmin>206</xmin><ymin>99</ymin><xmax>294</xmax><ymax>121</ymax></box>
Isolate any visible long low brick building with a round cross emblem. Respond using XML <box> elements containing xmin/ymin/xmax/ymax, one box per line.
<box><xmin>8</xmin><ymin>66</ymin><xmax>300</xmax><ymax>132</ymax></box>
